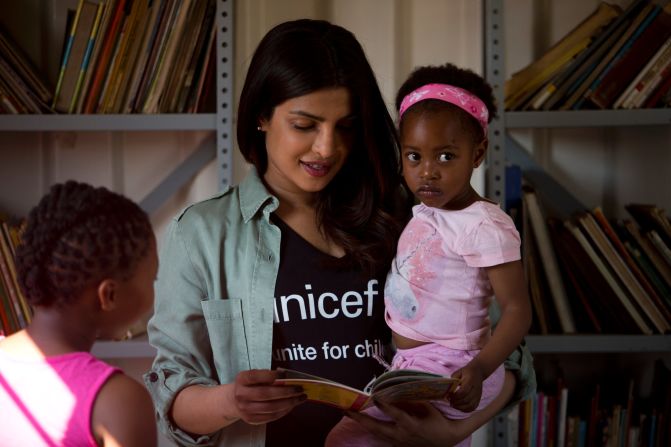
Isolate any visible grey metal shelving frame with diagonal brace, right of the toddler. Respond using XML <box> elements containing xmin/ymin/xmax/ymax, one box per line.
<box><xmin>482</xmin><ymin>0</ymin><xmax>671</xmax><ymax>446</ymax></box>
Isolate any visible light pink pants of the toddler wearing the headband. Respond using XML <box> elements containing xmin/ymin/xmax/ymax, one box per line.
<box><xmin>324</xmin><ymin>343</ymin><xmax>505</xmax><ymax>447</ymax></box>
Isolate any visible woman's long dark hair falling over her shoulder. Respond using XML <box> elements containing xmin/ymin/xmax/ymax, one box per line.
<box><xmin>242</xmin><ymin>19</ymin><xmax>406</xmax><ymax>274</ymax></box>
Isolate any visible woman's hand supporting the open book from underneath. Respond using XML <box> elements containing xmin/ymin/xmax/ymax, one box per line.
<box><xmin>347</xmin><ymin>402</ymin><xmax>470</xmax><ymax>447</ymax></box>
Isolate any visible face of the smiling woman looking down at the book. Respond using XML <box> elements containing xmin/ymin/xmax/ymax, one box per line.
<box><xmin>260</xmin><ymin>87</ymin><xmax>356</xmax><ymax>198</ymax></box>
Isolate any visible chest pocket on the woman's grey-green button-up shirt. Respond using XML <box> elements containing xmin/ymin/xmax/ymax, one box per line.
<box><xmin>201</xmin><ymin>298</ymin><xmax>250</xmax><ymax>383</ymax></box>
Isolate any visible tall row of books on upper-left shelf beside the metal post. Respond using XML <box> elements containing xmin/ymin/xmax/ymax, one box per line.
<box><xmin>52</xmin><ymin>0</ymin><xmax>216</xmax><ymax>113</ymax></box>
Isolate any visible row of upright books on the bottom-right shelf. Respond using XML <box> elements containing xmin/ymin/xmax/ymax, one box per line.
<box><xmin>508</xmin><ymin>359</ymin><xmax>671</xmax><ymax>447</ymax></box>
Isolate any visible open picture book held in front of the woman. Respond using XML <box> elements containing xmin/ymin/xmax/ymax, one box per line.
<box><xmin>275</xmin><ymin>368</ymin><xmax>459</xmax><ymax>411</ymax></box>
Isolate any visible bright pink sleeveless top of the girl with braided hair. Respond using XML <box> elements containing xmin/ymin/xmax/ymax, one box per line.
<box><xmin>0</xmin><ymin>351</ymin><xmax>120</xmax><ymax>447</ymax></box>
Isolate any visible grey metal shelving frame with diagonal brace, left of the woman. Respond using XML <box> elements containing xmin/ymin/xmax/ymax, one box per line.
<box><xmin>0</xmin><ymin>0</ymin><xmax>234</xmax><ymax>359</ymax></box>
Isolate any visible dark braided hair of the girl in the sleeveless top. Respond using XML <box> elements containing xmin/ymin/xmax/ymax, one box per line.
<box><xmin>16</xmin><ymin>181</ymin><xmax>154</xmax><ymax>307</ymax></box>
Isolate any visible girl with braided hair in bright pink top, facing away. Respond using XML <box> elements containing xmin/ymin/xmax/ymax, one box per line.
<box><xmin>0</xmin><ymin>181</ymin><xmax>158</xmax><ymax>447</ymax></box>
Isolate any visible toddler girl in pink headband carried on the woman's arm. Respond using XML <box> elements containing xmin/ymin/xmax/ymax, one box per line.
<box><xmin>327</xmin><ymin>64</ymin><xmax>531</xmax><ymax>446</ymax></box>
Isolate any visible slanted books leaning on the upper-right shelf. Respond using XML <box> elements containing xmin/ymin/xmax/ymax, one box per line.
<box><xmin>505</xmin><ymin>0</ymin><xmax>671</xmax><ymax>110</ymax></box>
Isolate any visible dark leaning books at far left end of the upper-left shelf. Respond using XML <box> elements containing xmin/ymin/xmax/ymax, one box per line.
<box><xmin>0</xmin><ymin>28</ymin><xmax>53</xmax><ymax>114</ymax></box>
